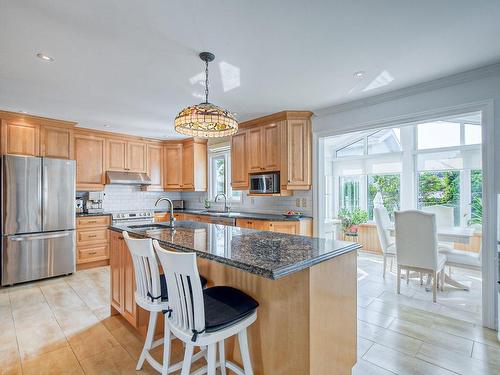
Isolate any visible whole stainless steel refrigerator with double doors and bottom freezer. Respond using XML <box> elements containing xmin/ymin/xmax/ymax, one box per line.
<box><xmin>0</xmin><ymin>155</ymin><xmax>76</xmax><ymax>286</ymax></box>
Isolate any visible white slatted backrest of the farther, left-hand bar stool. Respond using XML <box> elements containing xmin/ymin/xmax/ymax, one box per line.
<box><xmin>123</xmin><ymin>231</ymin><xmax>161</xmax><ymax>308</ymax></box>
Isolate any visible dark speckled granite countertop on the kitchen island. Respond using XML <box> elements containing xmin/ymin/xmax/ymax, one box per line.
<box><xmin>110</xmin><ymin>221</ymin><xmax>361</xmax><ymax>279</ymax></box>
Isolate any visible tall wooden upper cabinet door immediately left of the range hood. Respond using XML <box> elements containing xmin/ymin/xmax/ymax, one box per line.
<box><xmin>74</xmin><ymin>134</ymin><xmax>105</xmax><ymax>190</ymax></box>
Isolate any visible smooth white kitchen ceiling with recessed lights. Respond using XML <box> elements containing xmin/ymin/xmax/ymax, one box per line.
<box><xmin>0</xmin><ymin>0</ymin><xmax>500</xmax><ymax>138</ymax></box>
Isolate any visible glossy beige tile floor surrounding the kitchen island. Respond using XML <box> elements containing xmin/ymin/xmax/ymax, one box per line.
<box><xmin>0</xmin><ymin>253</ymin><xmax>500</xmax><ymax>375</ymax></box>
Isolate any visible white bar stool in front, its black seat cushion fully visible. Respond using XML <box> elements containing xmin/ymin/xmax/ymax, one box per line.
<box><xmin>153</xmin><ymin>240</ymin><xmax>259</xmax><ymax>375</ymax></box>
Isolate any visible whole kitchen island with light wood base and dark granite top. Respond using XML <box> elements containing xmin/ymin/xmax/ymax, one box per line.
<box><xmin>110</xmin><ymin>222</ymin><xmax>359</xmax><ymax>375</ymax></box>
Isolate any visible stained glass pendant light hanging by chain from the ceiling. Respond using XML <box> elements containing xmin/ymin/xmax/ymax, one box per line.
<box><xmin>174</xmin><ymin>52</ymin><xmax>238</xmax><ymax>138</ymax></box>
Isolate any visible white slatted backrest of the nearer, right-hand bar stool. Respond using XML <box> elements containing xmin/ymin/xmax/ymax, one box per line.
<box><xmin>153</xmin><ymin>240</ymin><xmax>205</xmax><ymax>334</ymax></box>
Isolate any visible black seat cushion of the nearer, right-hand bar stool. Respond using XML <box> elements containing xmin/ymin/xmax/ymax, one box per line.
<box><xmin>203</xmin><ymin>286</ymin><xmax>259</xmax><ymax>332</ymax></box>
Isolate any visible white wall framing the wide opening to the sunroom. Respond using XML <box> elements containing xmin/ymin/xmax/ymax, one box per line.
<box><xmin>313</xmin><ymin>64</ymin><xmax>500</xmax><ymax>327</ymax></box>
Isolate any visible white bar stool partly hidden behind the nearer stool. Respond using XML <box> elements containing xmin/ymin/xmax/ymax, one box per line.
<box><xmin>122</xmin><ymin>231</ymin><xmax>207</xmax><ymax>374</ymax></box>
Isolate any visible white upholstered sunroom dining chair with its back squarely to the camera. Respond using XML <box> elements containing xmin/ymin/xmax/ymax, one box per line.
<box><xmin>395</xmin><ymin>210</ymin><xmax>446</xmax><ymax>302</ymax></box>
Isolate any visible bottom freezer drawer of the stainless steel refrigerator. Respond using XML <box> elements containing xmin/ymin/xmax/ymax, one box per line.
<box><xmin>1</xmin><ymin>231</ymin><xmax>75</xmax><ymax>285</ymax></box>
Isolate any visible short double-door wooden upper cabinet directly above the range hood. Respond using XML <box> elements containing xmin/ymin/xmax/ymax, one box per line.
<box><xmin>106</xmin><ymin>138</ymin><xmax>147</xmax><ymax>173</ymax></box>
